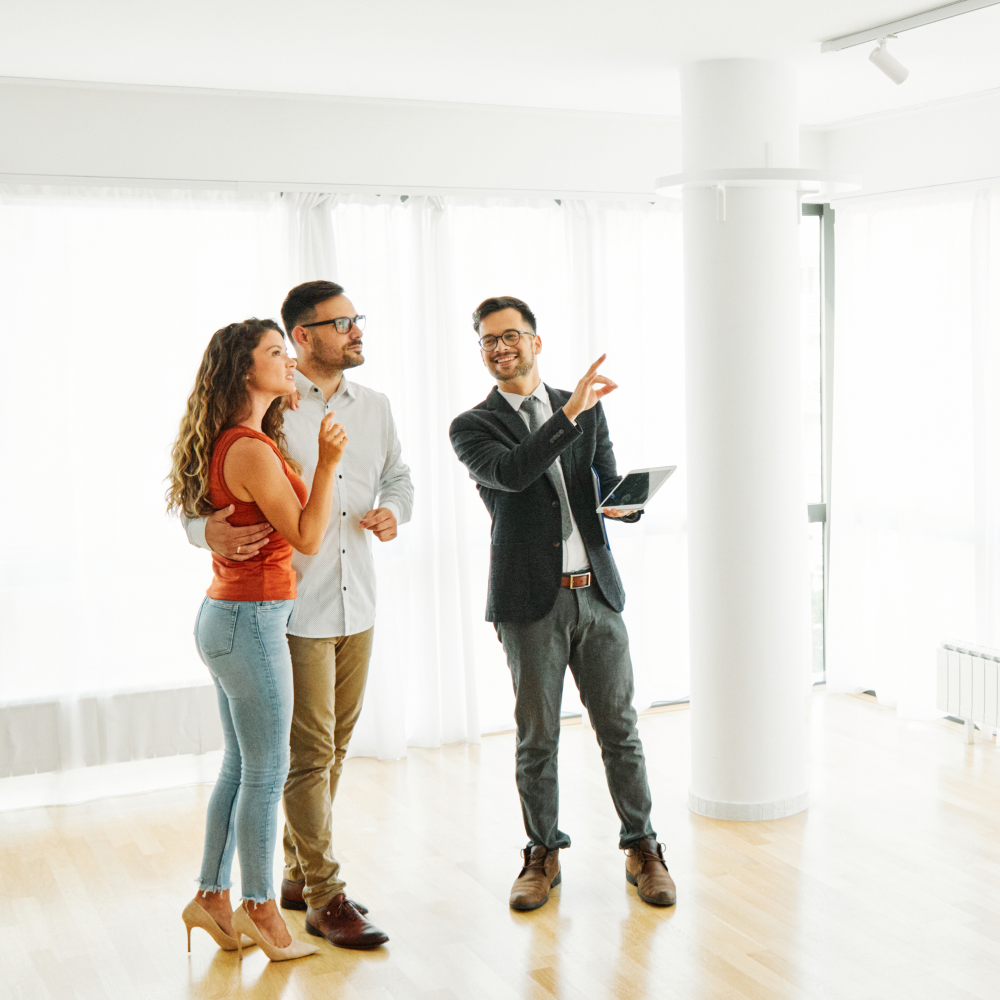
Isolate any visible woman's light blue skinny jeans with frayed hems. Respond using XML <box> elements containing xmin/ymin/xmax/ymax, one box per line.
<box><xmin>194</xmin><ymin>597</ymin><xmax>294</xmax><ymax>903</ymax></box>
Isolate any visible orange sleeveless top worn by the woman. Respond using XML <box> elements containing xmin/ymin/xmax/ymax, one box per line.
<box><xmin>208</xmin><ymin>427</ymin><xmax>308</xmax><ymax>601</ymax></box>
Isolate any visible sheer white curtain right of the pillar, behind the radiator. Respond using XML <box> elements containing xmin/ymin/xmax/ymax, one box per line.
<box><xmin>827</xmin><ymin>189</ymin><xmax>1000</xmax><ymax>718</ymax></box>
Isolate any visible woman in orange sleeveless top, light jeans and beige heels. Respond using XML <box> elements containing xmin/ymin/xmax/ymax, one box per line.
<box><xmin>167</xmin><ymin>319</ymin><xmax>347</xmax><ymax>961</ymax></box>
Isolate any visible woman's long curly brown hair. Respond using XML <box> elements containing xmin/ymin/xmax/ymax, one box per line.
<box><xmin>166</xmin><ymin>317</ymin><xmax>301</xmax><ymax>517</ymax></box>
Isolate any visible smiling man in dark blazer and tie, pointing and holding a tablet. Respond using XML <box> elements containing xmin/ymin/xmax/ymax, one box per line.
<box><xmin>451</xmin><ymin>297</ymin><xmax>676</xmax><ymax>910</ymax></box>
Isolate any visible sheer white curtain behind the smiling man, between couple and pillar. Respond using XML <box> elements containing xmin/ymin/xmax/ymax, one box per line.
<box><xmin>318</xmin><ymin>197</ymin><xmax>688</xmax><ymax>757</ymax></box>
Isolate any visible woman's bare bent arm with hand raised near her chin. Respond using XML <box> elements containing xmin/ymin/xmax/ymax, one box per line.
<box><xmin>223</xmin><ymin>413</ymin><xmax>347</xmax><ymax>555</ymax></box>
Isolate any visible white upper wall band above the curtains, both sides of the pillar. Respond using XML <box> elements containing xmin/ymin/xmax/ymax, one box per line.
<box><xmin>9</xmin><ymin>79</ymin><xmax>1000</xmax><ymax>197</ymax></box>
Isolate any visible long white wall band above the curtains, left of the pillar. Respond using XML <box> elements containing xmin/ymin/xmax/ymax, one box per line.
<box><xmin>0</xmin><ymin>79</ymin><xmax>680</xmax><ymax>196</ymax></box>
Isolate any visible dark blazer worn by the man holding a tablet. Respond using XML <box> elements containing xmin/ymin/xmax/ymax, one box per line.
<box><xmin>451</xmin><ymin>385</ymin><xmax>641</xmax><ymax>622</ymax></box>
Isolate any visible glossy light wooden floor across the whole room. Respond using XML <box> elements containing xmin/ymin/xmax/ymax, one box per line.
<box><xmin>0</xmin><ymin>691</ymin><xmax>1000</xmax><ymax>1000</ymax></box>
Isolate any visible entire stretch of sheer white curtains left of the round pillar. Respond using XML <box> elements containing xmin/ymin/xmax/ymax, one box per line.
<box><xmin>0</xmin><ymin>187</ymin><xmax>688</xmax><ymax>799</ymax></box>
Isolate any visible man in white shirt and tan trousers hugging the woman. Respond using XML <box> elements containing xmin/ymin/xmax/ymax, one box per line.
<box><xmin>187</xmin><ymin>281</ymin><xmax>413</xmax><ymax>949</ymax></box>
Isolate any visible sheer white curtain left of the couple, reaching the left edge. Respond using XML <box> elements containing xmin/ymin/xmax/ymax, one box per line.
<box><xmin>0</xmin><ymin>187</ymin><xmax>290</xmax><ymax>795</ymax></box>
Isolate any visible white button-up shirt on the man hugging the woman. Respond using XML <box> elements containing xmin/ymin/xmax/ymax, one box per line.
<box><xmin>185</xmin><ymin>371</ymin><xmax>413</xmax><ymax>639</ymax></box>
